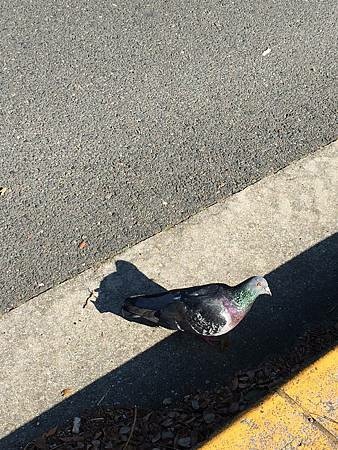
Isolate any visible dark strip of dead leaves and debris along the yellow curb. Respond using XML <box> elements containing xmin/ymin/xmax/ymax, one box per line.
<box><xmin>25</xmin><ymin>326</ymin><xmax>338</xmax><ymax>450</ymax></box>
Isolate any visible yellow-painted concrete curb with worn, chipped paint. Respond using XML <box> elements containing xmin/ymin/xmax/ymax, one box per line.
<box><xmin>201</xmin><ymin>349</ymin><xmax>338</xmax><ymax>450</ymax></box>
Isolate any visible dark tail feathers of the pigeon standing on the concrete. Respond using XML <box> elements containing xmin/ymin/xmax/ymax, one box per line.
<box><xmin>121</xmin><ymin>296</ymin><xmax>159</xmax><ymax>326</ymax></box>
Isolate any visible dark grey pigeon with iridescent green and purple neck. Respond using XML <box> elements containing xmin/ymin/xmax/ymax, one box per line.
<box><xmin>121</xmin><ymin>276</ymin><xmax>272</xmax><ymax>343</ymax></box>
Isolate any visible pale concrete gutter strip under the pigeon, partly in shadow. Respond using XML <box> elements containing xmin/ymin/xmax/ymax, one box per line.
<box><xmin>0</xmin><ymin>143</ymin><xmax>338</xmax><ymax>450</ymax></box>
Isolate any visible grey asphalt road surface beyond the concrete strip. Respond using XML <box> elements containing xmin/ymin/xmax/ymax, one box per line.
<box><xmin>0</xmin><ymin>0</ymin><xmax>337</xmax><ymax>311</ymax></box>
